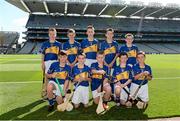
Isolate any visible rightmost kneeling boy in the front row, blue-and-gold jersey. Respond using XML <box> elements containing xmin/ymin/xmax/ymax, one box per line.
<box><xmin>130</xmin><ymin>51</ymin><xmax>152</xmax><ymax>109</ymax></box>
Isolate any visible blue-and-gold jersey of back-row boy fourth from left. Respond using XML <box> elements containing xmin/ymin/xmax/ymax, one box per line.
<box><xmin>100</xmin><ymin>41</ymin><xmax>119</xmax><ymax>68</ymax></box>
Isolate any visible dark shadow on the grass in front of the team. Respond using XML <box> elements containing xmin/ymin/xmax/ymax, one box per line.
<box><xmin>0</xmin><ymin>100</ymin><xmax>179</xmax><ymax>120</ymax></box>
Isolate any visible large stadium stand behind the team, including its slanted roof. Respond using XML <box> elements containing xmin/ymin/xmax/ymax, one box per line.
<box><xmin>6</xmin><ymin>0</ymin><xmax>180</xmax><ymax>54</ymax></box>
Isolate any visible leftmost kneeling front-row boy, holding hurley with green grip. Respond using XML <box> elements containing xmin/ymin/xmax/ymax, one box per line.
<box><xmin>47</xmin><ymin>51</ymin><xmax>71</xmax><ymax>111</ymax></box>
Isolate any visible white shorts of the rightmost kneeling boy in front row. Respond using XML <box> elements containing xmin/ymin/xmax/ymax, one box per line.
<box><xmin>130</xmin><ymin>83</ymin><xmax>149</xmax><ymax>102</ymax></box>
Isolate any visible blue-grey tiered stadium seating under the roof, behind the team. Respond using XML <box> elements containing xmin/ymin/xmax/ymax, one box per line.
<box><xmin>14</xmin><ymin>15</ymin><xmax>180</xmax><ymax>53</ymax></box>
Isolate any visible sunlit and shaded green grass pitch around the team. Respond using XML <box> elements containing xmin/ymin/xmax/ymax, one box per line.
<box><xmin>0</xmin><ymin>55</ymin><xmax>180</xmax><ymax>120</ymax></box>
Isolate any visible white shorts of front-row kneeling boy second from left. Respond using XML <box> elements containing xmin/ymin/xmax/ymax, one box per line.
<box><xmin>72</xmin><ymin>86</ymin><xmax>89</xmax><ymax>104</ymax></box>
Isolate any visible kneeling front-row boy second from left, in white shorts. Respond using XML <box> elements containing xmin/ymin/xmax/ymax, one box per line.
<box><xmin>72</xmin><ymin>53</ymin><xmax>91</xmax><ymax>108</ymax></box>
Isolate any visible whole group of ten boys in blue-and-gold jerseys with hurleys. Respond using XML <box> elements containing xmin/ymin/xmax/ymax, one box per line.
<box><xmin>40</xmin><ymin>25</ymin><xmax>152</xmax><ymax>114</ymax></box>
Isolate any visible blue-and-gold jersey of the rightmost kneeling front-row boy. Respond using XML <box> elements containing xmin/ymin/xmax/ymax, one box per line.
<box><xmin>132</xmin><ymin>64</ymin><xmax>152</xmax><ymax>85</ymax></box>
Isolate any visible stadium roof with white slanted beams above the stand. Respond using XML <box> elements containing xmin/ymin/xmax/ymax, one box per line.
<box><xmin>6</xmin><ymin>0</ymin><xmax>180</xmax><ymax>18</ymax></box>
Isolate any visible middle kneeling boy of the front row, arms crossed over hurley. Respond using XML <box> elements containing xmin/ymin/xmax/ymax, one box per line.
<box><xmin>91</xmin><ymin>51</ymin><xmax>111</xmax><ymax>109</ymax></box>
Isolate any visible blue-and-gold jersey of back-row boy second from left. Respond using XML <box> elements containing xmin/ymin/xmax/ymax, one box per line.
<box><xmin>62</xmin><ymin>41</ymin><xmax>80</xmax><ymax>63</ymax></box>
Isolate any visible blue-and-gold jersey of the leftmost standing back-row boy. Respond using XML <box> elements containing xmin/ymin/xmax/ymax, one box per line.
<box><xmin>40</xmin><ymin>41</ymin><xmax>61</xmax><ymax>61</ymax></box>
